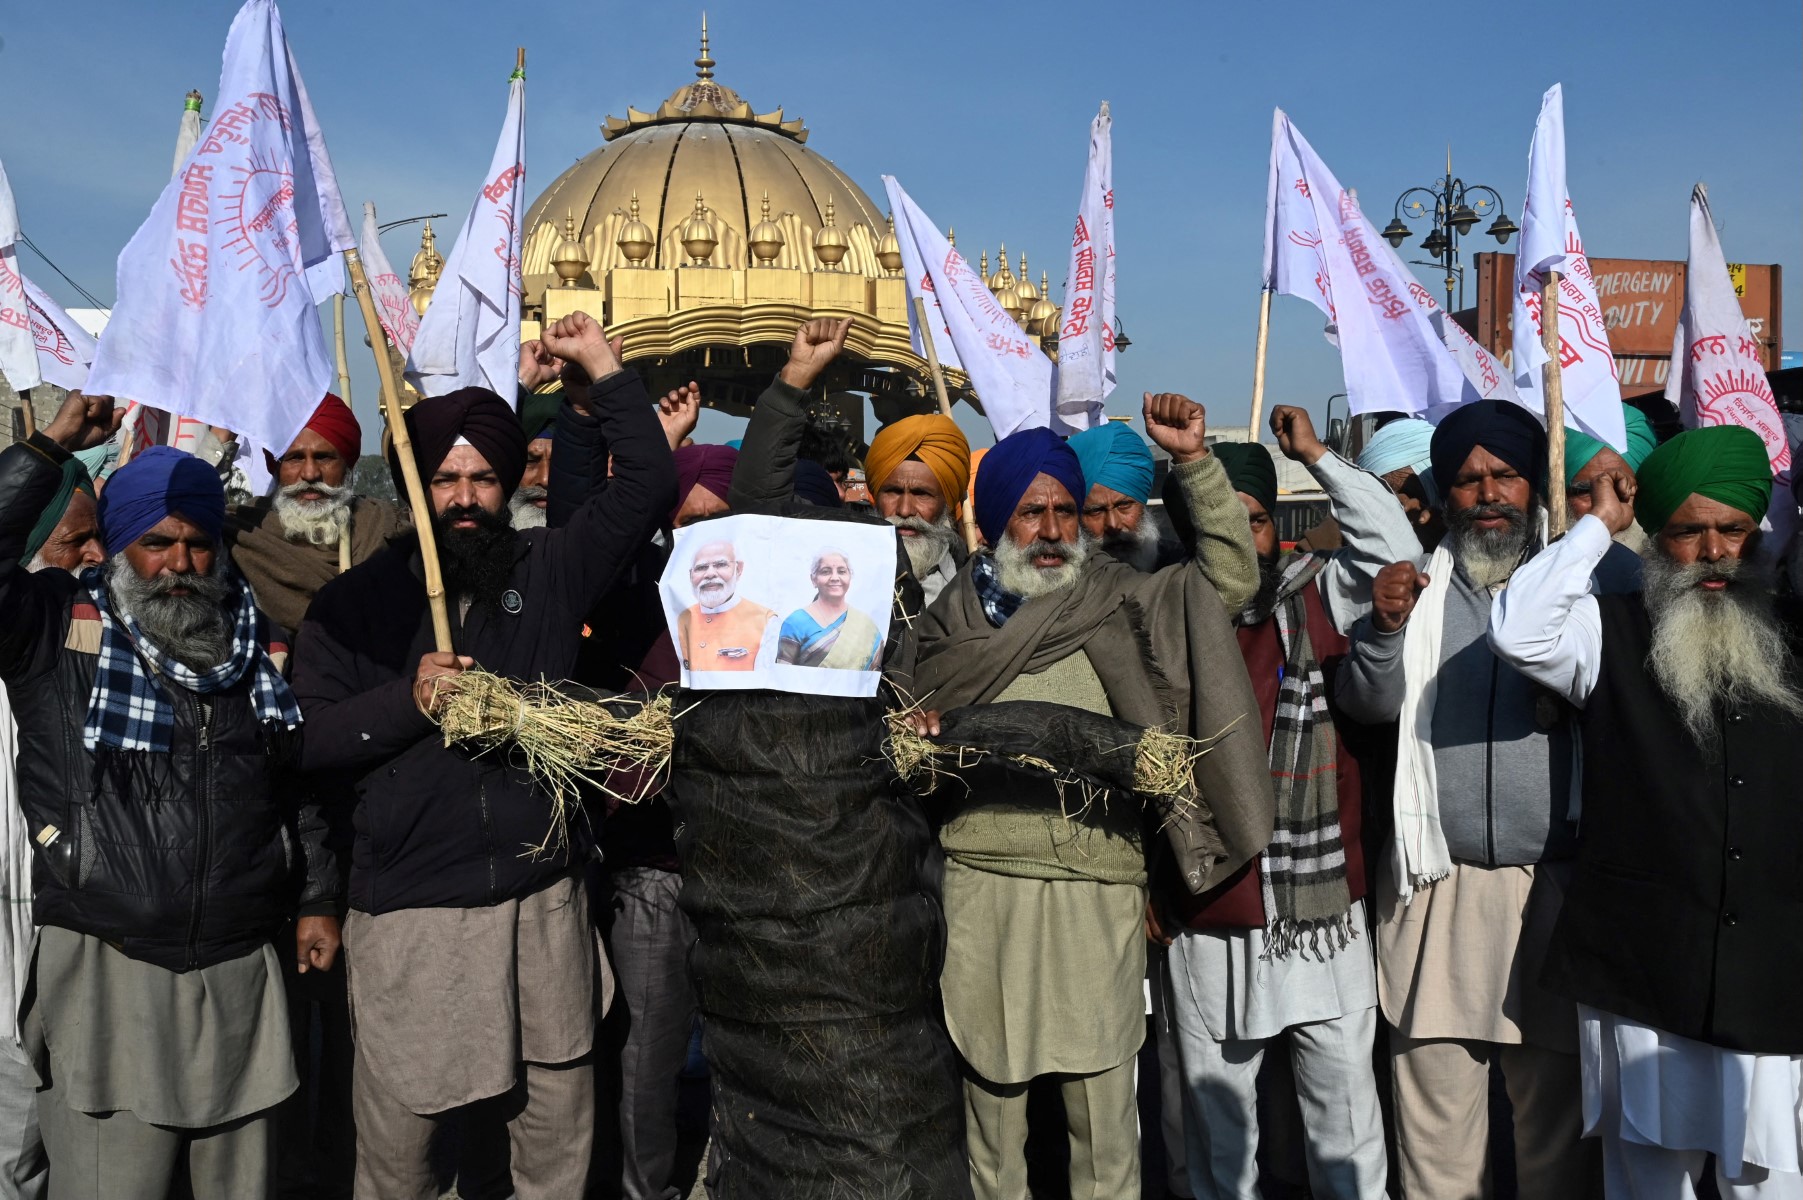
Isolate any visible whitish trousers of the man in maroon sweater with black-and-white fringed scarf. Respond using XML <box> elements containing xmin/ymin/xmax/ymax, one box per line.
<box><xmin>1177</xmin><ymin>1009</ymin><xmax>1384</xmax><ymax>1200</ymax></box>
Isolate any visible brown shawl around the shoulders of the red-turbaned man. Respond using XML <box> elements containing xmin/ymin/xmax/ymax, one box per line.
<box><xmin>225</xmin><ymin>495</ymin><xmax>413</xmax><ymax>631</ymax></box>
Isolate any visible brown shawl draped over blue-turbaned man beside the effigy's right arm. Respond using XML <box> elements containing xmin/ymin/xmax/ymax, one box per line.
<box><xmin>909</xmin><ymin>551</ymin><xmax>1275</xmax><ymax>894</ymax></box>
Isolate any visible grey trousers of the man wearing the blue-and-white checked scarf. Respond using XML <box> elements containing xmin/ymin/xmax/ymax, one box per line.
<box><xmin>38</xmin><ymin>1085</ymin><xmax>276</xmax><ymax>1200</ymax></box>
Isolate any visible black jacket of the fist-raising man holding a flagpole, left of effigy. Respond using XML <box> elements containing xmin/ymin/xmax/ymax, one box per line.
<box><xmin>294</xmin><ymin>371</ymin><xmax>676</xmax><ymax>914</ymax></box>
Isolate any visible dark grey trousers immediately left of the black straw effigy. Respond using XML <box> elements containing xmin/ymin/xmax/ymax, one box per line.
<box><xmin>604</xmin><ymin>868</ymin><xmax>694</xmax><ymax>1200</ymax></box>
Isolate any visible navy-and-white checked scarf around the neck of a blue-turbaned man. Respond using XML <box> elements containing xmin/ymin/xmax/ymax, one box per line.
<box><xmin>81</xmin><ymin>566</ymin><xmax>301</xmax><ymax>753</ymax></box>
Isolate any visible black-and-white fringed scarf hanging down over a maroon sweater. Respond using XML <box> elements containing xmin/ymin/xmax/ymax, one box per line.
<box><xmin>1235</xmin><ymin>553</ymin><xmax>1356</xmax><ymax>959</ymax></box>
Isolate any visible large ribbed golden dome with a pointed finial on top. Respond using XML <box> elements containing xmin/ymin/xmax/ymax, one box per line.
<box><xmin>523</xmin><ymin>20</ymin><xmax>883</xmax><ymax>293</ymax></box>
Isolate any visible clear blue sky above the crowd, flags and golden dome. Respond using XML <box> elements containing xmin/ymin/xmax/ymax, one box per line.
<box><xmin>0</xmin><ymin>0</ymin><xmax>1803</xmax><ymax>448</ymax></box>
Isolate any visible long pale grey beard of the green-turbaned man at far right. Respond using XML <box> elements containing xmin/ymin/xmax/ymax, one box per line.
<box><xmin>1641</xmin><ymin>539</ymin><xmax>1803</xmax><ymax>748</ymax></box>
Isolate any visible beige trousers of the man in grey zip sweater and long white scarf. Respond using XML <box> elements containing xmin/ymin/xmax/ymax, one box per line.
<box><xmin>1390</xmin><ymin>1029</ymin><xmax>1603</xmax><ymax>1200</ymax></box>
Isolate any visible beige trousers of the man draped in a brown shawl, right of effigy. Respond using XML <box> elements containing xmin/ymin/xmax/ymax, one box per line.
<box><xmin>965</xmin><ymin>1058</ymin><xmax>1139</xmax><ymax>1200</ymax></box>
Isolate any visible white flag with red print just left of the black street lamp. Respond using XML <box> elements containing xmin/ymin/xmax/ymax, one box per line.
<box><xmin>1264</xmin><ymin>110</ymin><xmax>1478</xmax><ymax>420</ymax></box>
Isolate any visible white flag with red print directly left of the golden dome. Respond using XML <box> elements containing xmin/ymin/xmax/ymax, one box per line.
<box><xmin>407</xmin><ymin>70</ymin><xmax>526</xmax><ymax>404</ymax></box>
